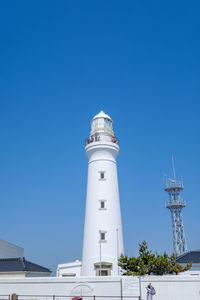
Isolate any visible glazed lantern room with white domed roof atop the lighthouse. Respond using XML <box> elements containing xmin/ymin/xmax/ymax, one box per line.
<box><xmin>90</xmin><ymin>110</ymin><xmax>114</xmax><ymax>135</ymax></box>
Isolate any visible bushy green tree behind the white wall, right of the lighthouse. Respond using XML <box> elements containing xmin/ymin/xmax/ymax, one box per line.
<box><xmin>119</xmin><ymin>241</ymin><xmax>192</xmax><ymax>275</ymax></box>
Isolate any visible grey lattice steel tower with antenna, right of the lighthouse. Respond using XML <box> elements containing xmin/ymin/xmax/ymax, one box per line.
<box><xmin>165</xmin><ymin>157</ymin><xmax>187</xmax><ymax>255</ymax></box>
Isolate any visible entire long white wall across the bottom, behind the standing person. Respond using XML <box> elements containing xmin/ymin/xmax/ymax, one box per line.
<box><xmin>0</xmin><ymin>275</ymin><xmax>200</xmax><ymax>300</ymax></box>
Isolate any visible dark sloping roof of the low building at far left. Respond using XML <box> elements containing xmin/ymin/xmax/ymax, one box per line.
<box><xmin>0</xmin><ymin>257</ymin><xmax>51</xmax><ymax>273</ymax></box>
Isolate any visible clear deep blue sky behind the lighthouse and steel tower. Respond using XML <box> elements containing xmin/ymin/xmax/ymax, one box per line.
<box><xmin>0</xmin><ymin>0</ymin><xmax>200</xmax><ymax>270</ymax></box>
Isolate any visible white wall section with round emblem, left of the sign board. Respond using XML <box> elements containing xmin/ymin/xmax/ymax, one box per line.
<box><xmin>0</xmin><ymin>277</ymin><xmax>124</xmax><ymax>300</ymax></box>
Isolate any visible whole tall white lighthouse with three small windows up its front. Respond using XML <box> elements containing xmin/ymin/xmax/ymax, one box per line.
<box><xmin>81</xmin><ymin>111</ymin><xmax>124</xmax><ymax>276</ymax></box>
